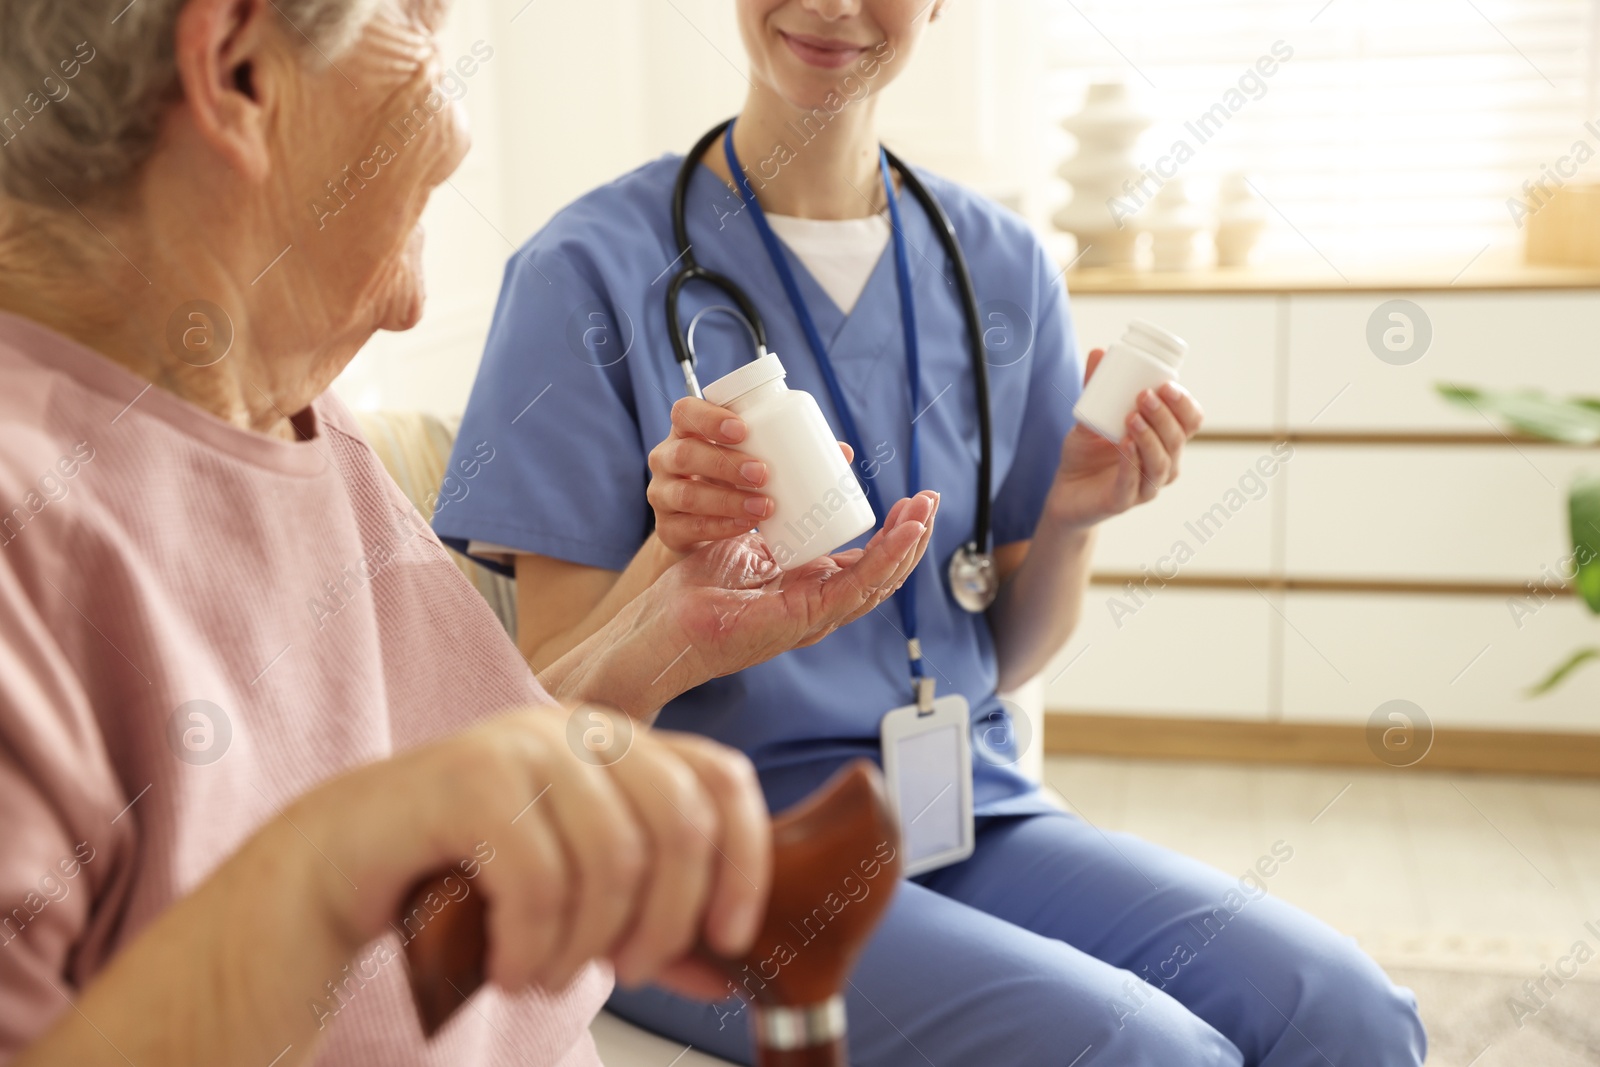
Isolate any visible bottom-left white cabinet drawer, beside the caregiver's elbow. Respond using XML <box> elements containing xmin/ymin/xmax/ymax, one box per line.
<box><xmin>1043</xmin><ymin>584</ymin><xmax>1274</xmax><ymax>720</ymax></box>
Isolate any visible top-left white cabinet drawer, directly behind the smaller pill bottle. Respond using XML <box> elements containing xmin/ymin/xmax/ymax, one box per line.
<box><xmin>1072</xmin><ymin>296</ymin><xmax>1278</xmax><ymax>430</ymax></box>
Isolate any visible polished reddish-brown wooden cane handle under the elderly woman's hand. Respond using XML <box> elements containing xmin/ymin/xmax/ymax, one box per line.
<box><xmin>400</xmin><ymin>760</ymin><xmax>901</xmax><ymax>1067</ymax></box>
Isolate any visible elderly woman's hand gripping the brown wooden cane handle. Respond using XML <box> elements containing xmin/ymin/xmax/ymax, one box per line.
<box><xmin>304</xmin><ymin>707</ymin><xmax>771</xmax><ymax>995</ymax></box>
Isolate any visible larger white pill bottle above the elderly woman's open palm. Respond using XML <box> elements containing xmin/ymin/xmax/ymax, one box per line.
<box><xmin>706</xmin><ymin>352</ymin><xmax>877</xmax><ymax>571</ymax></box>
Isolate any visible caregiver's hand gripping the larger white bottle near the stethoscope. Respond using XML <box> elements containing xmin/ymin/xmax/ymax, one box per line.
<box><xmin>646</xmin><ymin>397</ymin><xmax>854</xmax><ymax>555</ymax></box>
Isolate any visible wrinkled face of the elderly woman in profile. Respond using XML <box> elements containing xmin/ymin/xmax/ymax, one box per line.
<box><xmin>274</xmin><ymin>0</ymin><xmax>475</xmax><ymax>346</ymax></box>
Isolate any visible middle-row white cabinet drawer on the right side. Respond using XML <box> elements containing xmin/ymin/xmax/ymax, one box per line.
<box><xmin>1280</xmin><ymin>445</ymin><xmax>1600</xmax><ymax>582</ymax></box>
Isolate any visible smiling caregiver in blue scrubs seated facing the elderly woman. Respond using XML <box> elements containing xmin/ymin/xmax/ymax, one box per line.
<box><xmin>435</xmin><ymin>0</ymin><xmax>1426</xmax><ymax>1067</ymax></box>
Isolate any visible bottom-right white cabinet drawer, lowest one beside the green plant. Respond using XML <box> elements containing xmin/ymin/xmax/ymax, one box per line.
<box><xmin>1283</xmin><ymin>593</ymin><xmax>1600</xmax><ymax>731</ymax></box>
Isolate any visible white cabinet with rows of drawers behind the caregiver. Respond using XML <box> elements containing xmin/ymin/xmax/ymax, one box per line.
<box><xmin>1045</xmin><ymin>285</ymin><xmax>1600</xmax><ymax>733</ymax></box>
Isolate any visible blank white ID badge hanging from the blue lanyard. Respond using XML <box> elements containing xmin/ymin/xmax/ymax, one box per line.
<box><xmin>878</xmin><ymin>694</ymin><xmax>974</xmax><ymax>877</ymax></box>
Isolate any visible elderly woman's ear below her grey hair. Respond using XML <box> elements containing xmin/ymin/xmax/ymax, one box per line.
<box><xmin>173</xmin><ymin>0</ymin><xmax>280</xmax><ymax>181</ymax></box>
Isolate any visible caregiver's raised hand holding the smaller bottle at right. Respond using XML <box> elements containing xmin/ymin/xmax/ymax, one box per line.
<box><xmin>1046</xmin><ymin>349</ymin><xmax>1205</xmax><ymax>528</ymax></box>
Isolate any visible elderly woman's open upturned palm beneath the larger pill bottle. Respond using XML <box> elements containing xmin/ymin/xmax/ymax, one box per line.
<box><xmin>653</xmin><ymin>491</ymin><xmax>939</xmax><ymax>680</ymax></box>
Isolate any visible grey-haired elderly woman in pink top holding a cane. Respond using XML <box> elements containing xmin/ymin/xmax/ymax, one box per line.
<box><xmin>0</xmin><ymin>0</ymin><xmax>936</xmax><ymax>1067</ymax></box>
